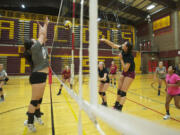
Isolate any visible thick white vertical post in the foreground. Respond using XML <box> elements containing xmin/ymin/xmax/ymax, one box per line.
<box><xmin>89</xmin><ymin>0</ymin><xmax>98</xmax><ymax>106</ymax></box>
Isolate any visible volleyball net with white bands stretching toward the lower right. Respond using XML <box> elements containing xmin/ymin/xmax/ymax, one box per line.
<box><xmin>50</xmin><ymin>0</ymin><xmax>179</xmax><ymax>135</ymax></box>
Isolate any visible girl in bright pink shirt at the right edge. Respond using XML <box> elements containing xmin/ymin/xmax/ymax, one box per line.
<box><xmin>164</xmin><ymin>66</ymin><xmax>180</xmax><ymax>120</ymax></box>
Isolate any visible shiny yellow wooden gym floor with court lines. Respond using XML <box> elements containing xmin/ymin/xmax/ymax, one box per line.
<box><xmin>0</xmin><ymin>75</ymin><xmax>180</xmax><ymax>135</ymax></box>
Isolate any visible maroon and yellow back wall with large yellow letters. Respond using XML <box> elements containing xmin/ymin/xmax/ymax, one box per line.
<box><xmin>0</xmin><ymin>9</ymin><xmax>141</xmax><ymax>75</ymax></box>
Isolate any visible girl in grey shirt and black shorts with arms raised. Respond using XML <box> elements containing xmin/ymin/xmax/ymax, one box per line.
<box><xmin>24</xmin><ymin>17</ymin><xmax>49</xmax><ymax>132</ymax></box>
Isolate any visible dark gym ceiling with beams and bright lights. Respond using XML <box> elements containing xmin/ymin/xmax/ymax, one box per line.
<box><xmin>0</xmin><ymin>0</ymin><xmax>180</xmax><ymax>25</ymax></box>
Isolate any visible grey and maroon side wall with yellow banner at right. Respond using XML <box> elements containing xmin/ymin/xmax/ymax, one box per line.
<box><xmin>137</xmin><ymin>11</ymin><xmax>180</xmax><ymax>73</ymax></box>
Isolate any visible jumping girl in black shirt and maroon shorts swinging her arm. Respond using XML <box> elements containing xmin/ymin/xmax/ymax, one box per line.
<box><xmin>100</xmin><ymin>39</ymin><xmax>135</xmax><ymax>111</ymax></box>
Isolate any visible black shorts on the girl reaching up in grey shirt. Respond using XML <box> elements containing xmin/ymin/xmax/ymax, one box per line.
<box><xmin>29</xmin><ymin>72</ymin><xmax>47</xmax><ymax>84</ymax></box>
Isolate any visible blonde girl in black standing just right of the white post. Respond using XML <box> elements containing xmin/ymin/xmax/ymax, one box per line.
<box><xmin>98</xmin><ymin>62</ymin><xmax>109</xmax><ymax>106</ymax></box>
